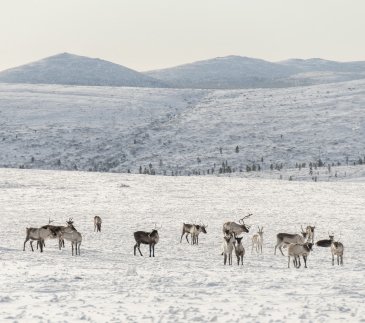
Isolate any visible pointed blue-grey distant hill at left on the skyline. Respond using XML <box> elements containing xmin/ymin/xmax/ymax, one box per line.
<box><xmin>0</xmin><ymin>53</ymin><xmax>166</xmax><ymax>87</ymax></box>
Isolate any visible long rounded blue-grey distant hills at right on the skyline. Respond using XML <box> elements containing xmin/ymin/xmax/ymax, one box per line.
<box><xmin>146</xmin><ymin>56</ymin><xmax>365</xmax><ymax>89</ymax></box>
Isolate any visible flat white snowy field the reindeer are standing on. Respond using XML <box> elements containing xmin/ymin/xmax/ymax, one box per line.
<box><xmin>0</xmin><ymin>169</ymin><xmax>365</xmax><ymax>322</ymax></box>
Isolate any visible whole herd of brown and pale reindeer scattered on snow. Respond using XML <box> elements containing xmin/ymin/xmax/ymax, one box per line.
<box><xmin>23</xmin><ymin>214</ymin><xmax>344</xmax><ymax>268</ymax></box>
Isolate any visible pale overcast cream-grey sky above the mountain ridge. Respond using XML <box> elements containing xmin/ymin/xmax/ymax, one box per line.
<box><xmin>0</xmin><ymin>0</ymin><xmax>365</xmax><ymax>71</ymax></box>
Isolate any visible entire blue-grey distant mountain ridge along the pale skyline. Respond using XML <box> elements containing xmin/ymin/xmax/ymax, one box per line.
<box><xmin>0</xmin><ymin>53</ymin><xmax>365</xmax><ymax>89</ymax></box>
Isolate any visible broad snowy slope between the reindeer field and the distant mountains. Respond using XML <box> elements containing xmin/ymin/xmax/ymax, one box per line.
<box><xmin>0</xmin><ymin>81</ymin><xmax>365</xmax><ymax>177</ymax></box>
